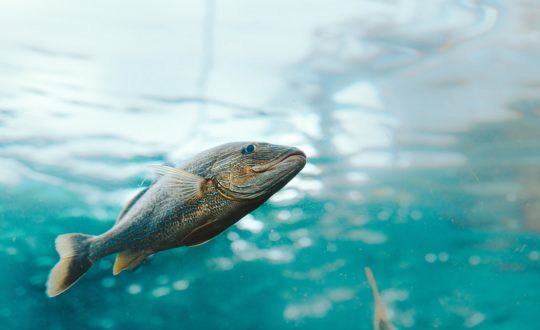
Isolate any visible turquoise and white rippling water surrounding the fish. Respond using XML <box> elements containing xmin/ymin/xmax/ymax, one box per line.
<box><xmin>0</xmin><ymin>0</ymin><xmax>540</xmax><ymax>329</ymax></box>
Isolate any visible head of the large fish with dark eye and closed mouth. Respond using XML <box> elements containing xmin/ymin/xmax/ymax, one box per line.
<box><xmin>211</xmin><ymin>142</ymin><xmax>306</xmax><ymax>200</ymax></box>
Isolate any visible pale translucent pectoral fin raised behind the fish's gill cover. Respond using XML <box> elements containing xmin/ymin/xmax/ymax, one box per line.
<box><xmin>150</xmin><ymin>165</ymin><xmax>205</xmax><ymax>200</ymax></box>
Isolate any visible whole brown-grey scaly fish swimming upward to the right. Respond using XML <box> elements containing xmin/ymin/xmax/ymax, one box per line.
<box><xmin>46</xmin><ymin>142</ymin><xmax>307</xmax><ymax>297</ymax></box>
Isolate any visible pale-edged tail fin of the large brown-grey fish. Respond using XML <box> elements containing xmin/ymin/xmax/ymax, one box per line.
<box><xmin>47</xmin><ymin>234</ymin><xmax>94</xmax><ymax>297</ymax></box>
